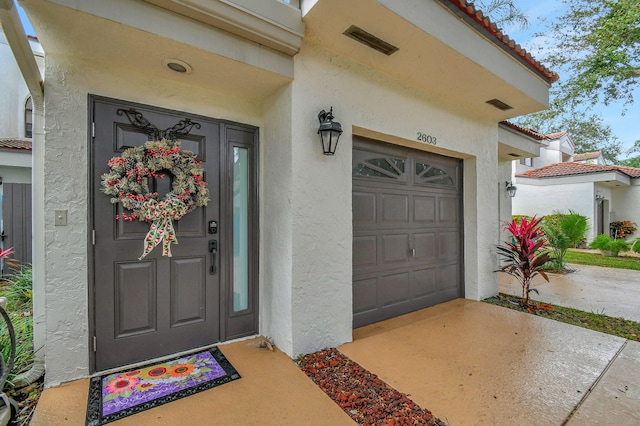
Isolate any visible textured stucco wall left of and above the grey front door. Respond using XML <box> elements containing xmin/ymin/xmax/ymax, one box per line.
<box><xmin>34</xmin><ymin>55</ymin><xmax>262</xmax><ymax>385</ymax></box>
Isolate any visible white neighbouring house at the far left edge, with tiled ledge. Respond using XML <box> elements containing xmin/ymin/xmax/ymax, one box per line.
<box><xmin>0</xmin><ymin>29</ymin><xmax>44</xmax><ymax>272</ymax></box>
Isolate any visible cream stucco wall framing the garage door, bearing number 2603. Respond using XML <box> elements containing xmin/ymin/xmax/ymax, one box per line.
<box><xmin>292</xmin><ymin>40</ymin><xmax>499</xmax><ymax>354</ymax></box>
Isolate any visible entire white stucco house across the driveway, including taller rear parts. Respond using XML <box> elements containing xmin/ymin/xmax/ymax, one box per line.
<box><xmin>512</xmin><ymin>132</ymin><xmax>640</xmax><ymax>241</ymax></box>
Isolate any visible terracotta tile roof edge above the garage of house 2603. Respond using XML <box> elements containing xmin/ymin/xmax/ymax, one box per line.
<box><xmin>440</xmin><ymin>0</ymin><xmax>560</xmax><ymax>83</ymax></box>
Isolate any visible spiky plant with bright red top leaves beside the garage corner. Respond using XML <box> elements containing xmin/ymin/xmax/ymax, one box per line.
<box><xmin>497</xmin><ymin>216</ymin><xmax>553</xmax><ymax>308</ymax></box>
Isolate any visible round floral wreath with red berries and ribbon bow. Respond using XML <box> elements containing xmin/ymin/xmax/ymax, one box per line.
<box><xmin>102</xmin><ymin>139</ymin><xmax>209</xmax><ymax>259</ymax></box>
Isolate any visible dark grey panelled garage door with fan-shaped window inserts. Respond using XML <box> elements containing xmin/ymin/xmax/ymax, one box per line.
<box><xmin>353</xmin><ymin>139</ymin><xmax>463</xmax><ymax>328</ymax></box>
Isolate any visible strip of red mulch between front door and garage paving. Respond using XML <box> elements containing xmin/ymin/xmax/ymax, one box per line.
<box><xmin>298</xmin><ymin>348</ymin><xmax>445</xmax><ymax>426</ymax></box>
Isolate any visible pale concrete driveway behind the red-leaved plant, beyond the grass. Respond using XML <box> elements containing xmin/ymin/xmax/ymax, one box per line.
<box><xmin>500</xmin><ymin>265</ymin><xmax>640</xmax><ymax>322</ymax></box>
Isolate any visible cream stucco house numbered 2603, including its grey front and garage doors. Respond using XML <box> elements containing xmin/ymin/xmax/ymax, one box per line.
<box><xmin>3</xmin><ymin>0</ymin><xmax>558</xmax><ymax>386</ymax></box>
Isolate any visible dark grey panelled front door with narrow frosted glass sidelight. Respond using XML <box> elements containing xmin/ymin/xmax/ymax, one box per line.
<box><xmin>90</xmin><ymin>98</ymin><xmax>257</xmax><ymax>371</ymax></box>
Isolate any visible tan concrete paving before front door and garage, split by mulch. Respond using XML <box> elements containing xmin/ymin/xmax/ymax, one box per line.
<box><xmin>31</xmin><ymin>299</ymin><xmax>640</xmax><ymax>426</ymax></box>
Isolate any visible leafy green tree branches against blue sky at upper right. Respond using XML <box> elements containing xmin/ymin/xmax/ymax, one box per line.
<box><xmin>545</xmin><ymin>0</ymin><xmax>640</xmax><ymax>107</ymax></box>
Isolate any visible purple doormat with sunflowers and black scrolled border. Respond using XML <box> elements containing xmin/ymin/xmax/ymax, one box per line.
<box><xmin>86</xmin><ymin>347</ymin><xmax>240</xmax><ymax>426</ymax></box>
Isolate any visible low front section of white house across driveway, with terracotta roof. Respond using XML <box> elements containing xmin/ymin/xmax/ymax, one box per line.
<box><xmin>513</xmin><ymin>160</ymin><xmax>640</xmax><ymax>240</ymax></box>
